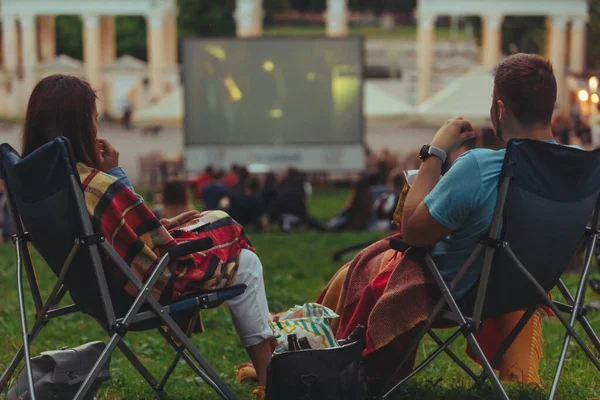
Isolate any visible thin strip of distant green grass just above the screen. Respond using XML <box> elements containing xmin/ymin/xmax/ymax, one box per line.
<box><xmin>263</xmin><ymin>25</ymin><xmax>464</xmax><ymax>40</ymax></box>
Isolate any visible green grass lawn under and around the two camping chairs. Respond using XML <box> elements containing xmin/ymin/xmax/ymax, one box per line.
<box><xmin>0</xmin><ymin>189</ymin><xmax>600</xmax><ymax>400</ymax></box>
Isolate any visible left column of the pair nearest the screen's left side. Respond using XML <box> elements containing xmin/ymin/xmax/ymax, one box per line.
<box><xmin>146</xmin><ymin>13</ymin><xmax>165</xmax><ymax>99</ymax></box>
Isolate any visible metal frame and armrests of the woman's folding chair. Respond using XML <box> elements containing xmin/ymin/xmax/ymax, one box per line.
<box><xmin>0</xmin><ymin>148</ymin><xmax>245</xmax><ymax>400</ymax></box>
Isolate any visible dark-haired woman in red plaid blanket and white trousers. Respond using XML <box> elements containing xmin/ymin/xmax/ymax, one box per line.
<box><xmin>23</xmin><ymin>75</ymin><xmax>272</xmax><ymax>398</ymax></box>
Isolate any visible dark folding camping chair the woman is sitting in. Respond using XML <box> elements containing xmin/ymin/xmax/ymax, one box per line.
<box><xmin>0</xmin><ymin>138</ymin><xmax>246</xmax><ymax>400</ymax></box>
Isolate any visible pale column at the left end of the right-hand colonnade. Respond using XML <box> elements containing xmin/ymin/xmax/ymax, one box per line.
<box><xmin>417</xmin><ymin>13</ymin><xmax>437</xmax><ymax>104</ymax></box>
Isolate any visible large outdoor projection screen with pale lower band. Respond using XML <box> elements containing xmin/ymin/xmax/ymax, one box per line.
<box><xmin>183</xmin><ymin>37</ymin><xmax>365</xmax><ymax>171</ymax></box>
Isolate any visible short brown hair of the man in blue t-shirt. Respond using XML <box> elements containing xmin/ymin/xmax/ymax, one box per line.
<box><xmin>494</xmin><ymin>53</ymin><xmax>556</xmax><ymax>126</ymax></box>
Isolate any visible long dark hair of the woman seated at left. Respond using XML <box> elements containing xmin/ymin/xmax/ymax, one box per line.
<box><xmin>22</xmin><ymin>75</ymin><xmax>100</xmax><ymax>168</ymax></box>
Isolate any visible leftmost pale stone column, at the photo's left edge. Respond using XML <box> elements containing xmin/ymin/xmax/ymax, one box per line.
<box><xmin>2</xmin><ymin>14</ymin><xmax>20</xmax><ymax>117</ymax></box>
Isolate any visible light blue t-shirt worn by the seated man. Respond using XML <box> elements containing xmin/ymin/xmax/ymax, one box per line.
<box><xmin>425</xmin><ymin>140</ymin><xmax>556</xmax><ymax>298</ymax></box>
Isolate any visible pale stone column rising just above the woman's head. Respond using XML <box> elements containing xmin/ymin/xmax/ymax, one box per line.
<box><xmin>82</xmin><ymin>14</ymin><xmax>104</xmax><ymax>114</ymax></box>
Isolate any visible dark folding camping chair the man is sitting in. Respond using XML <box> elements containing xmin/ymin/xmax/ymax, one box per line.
<box><xmin>381</xmin><ymin>140</ymin><xmax>600</xmax><ymax>399</ymax></box>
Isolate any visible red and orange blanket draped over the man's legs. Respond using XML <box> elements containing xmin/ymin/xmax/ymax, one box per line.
<box><xmin>317</xmin><ymin>239</ymin><xmax>542</xmax><ymax>385</ymax></box>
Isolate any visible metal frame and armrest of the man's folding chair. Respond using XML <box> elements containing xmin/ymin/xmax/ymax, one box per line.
<box><xmin>378</xmin><ymin>158</ymin><xmax>600</xmax><ymax>400</ymax></box>
